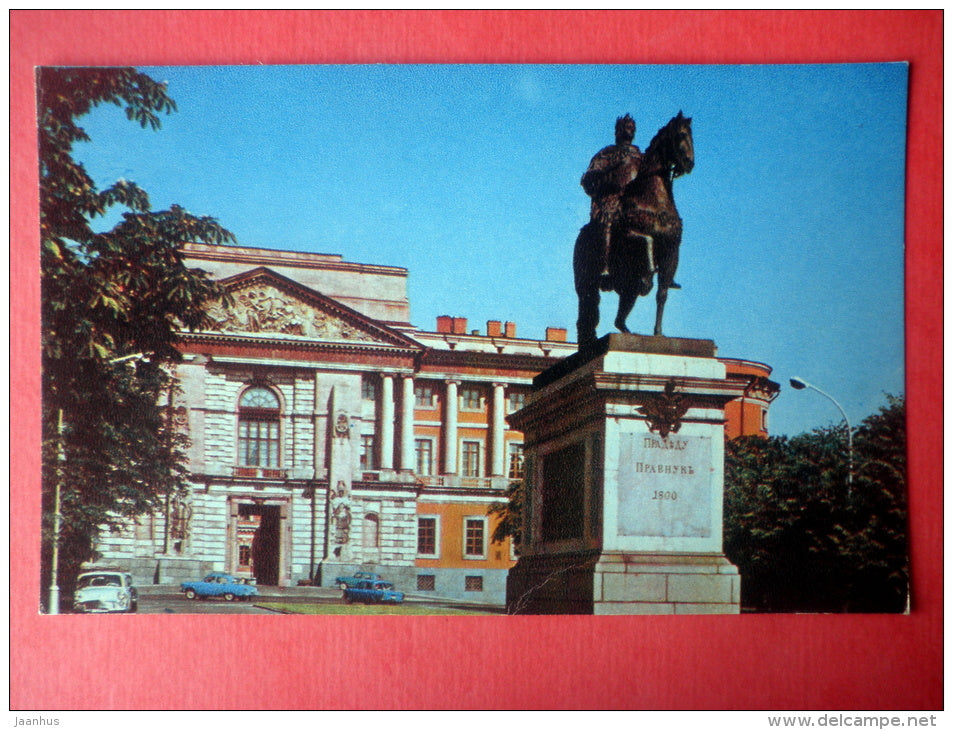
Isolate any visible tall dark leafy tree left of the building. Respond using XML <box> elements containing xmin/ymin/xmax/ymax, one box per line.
<box><xmin>37</xmin><ymin>68</ymin><xmax>234</xmax><ymax>612</ymax></box>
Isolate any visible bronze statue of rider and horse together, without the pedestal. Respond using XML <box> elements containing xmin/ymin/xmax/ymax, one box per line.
<box><xmin>573</xmin><ymin>112</ymin><xmax>695</xmax><ymax>348</ymax></box>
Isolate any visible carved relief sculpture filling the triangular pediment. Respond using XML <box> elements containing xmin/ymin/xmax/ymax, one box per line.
<box><xmin>207</xmin><ymin>285</ymin><xmax>372</xmax><ymax>341</ymax></box>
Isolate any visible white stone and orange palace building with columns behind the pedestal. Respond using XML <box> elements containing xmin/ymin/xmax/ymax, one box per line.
<box><xmin>99</xmin><ymin>244</ymin><xmax>778</xmax><ymax>604</ymax></box>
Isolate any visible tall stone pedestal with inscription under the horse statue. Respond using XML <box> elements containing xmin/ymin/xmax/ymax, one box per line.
<box><xmin>507</xmin><ymin>334</ymin><xmax>744</xmax><ymax>614</ymax></box>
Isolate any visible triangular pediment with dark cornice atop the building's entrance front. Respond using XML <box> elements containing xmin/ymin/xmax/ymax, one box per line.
<box><xmin>203</xmin><ymin>268</ymin><xmax>419</xmax><ymax>347</ymax></box>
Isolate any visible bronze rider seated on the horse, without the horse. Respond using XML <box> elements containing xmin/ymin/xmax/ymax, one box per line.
<box><xmin>581</xmin><ymin>114</ymin><xmax>642</xmax><ymax>275</ymax></box>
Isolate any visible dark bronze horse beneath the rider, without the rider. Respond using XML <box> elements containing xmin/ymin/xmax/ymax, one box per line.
<box><xmin>573</xmin><ymin>112</ymin><xmax>695</xmax><ymax>348</ymax></box>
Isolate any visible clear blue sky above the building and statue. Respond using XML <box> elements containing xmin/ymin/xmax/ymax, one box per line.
<box><xmin>70</xmin><ymin>64</ymin><xmax>907</xmax><ymax>434</ymax></box>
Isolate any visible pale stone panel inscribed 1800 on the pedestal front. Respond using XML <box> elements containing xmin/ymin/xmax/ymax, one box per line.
<box><xmin>618</xmin><ymin>433</ymin><xmax>712</xmax><ymax>537</ymax></box>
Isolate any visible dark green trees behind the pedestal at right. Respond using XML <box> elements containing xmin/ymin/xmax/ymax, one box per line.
<box><xmin>725</xmin><ymin>397</ymin><xmax>907</xmax><ymax>612</ymax></box>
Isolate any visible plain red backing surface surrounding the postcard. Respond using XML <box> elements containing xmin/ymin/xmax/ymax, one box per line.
<box><xmin>10</xmin><ymin>10</ymin><xmax>943</xmax><ymax>710</ymax></box>
